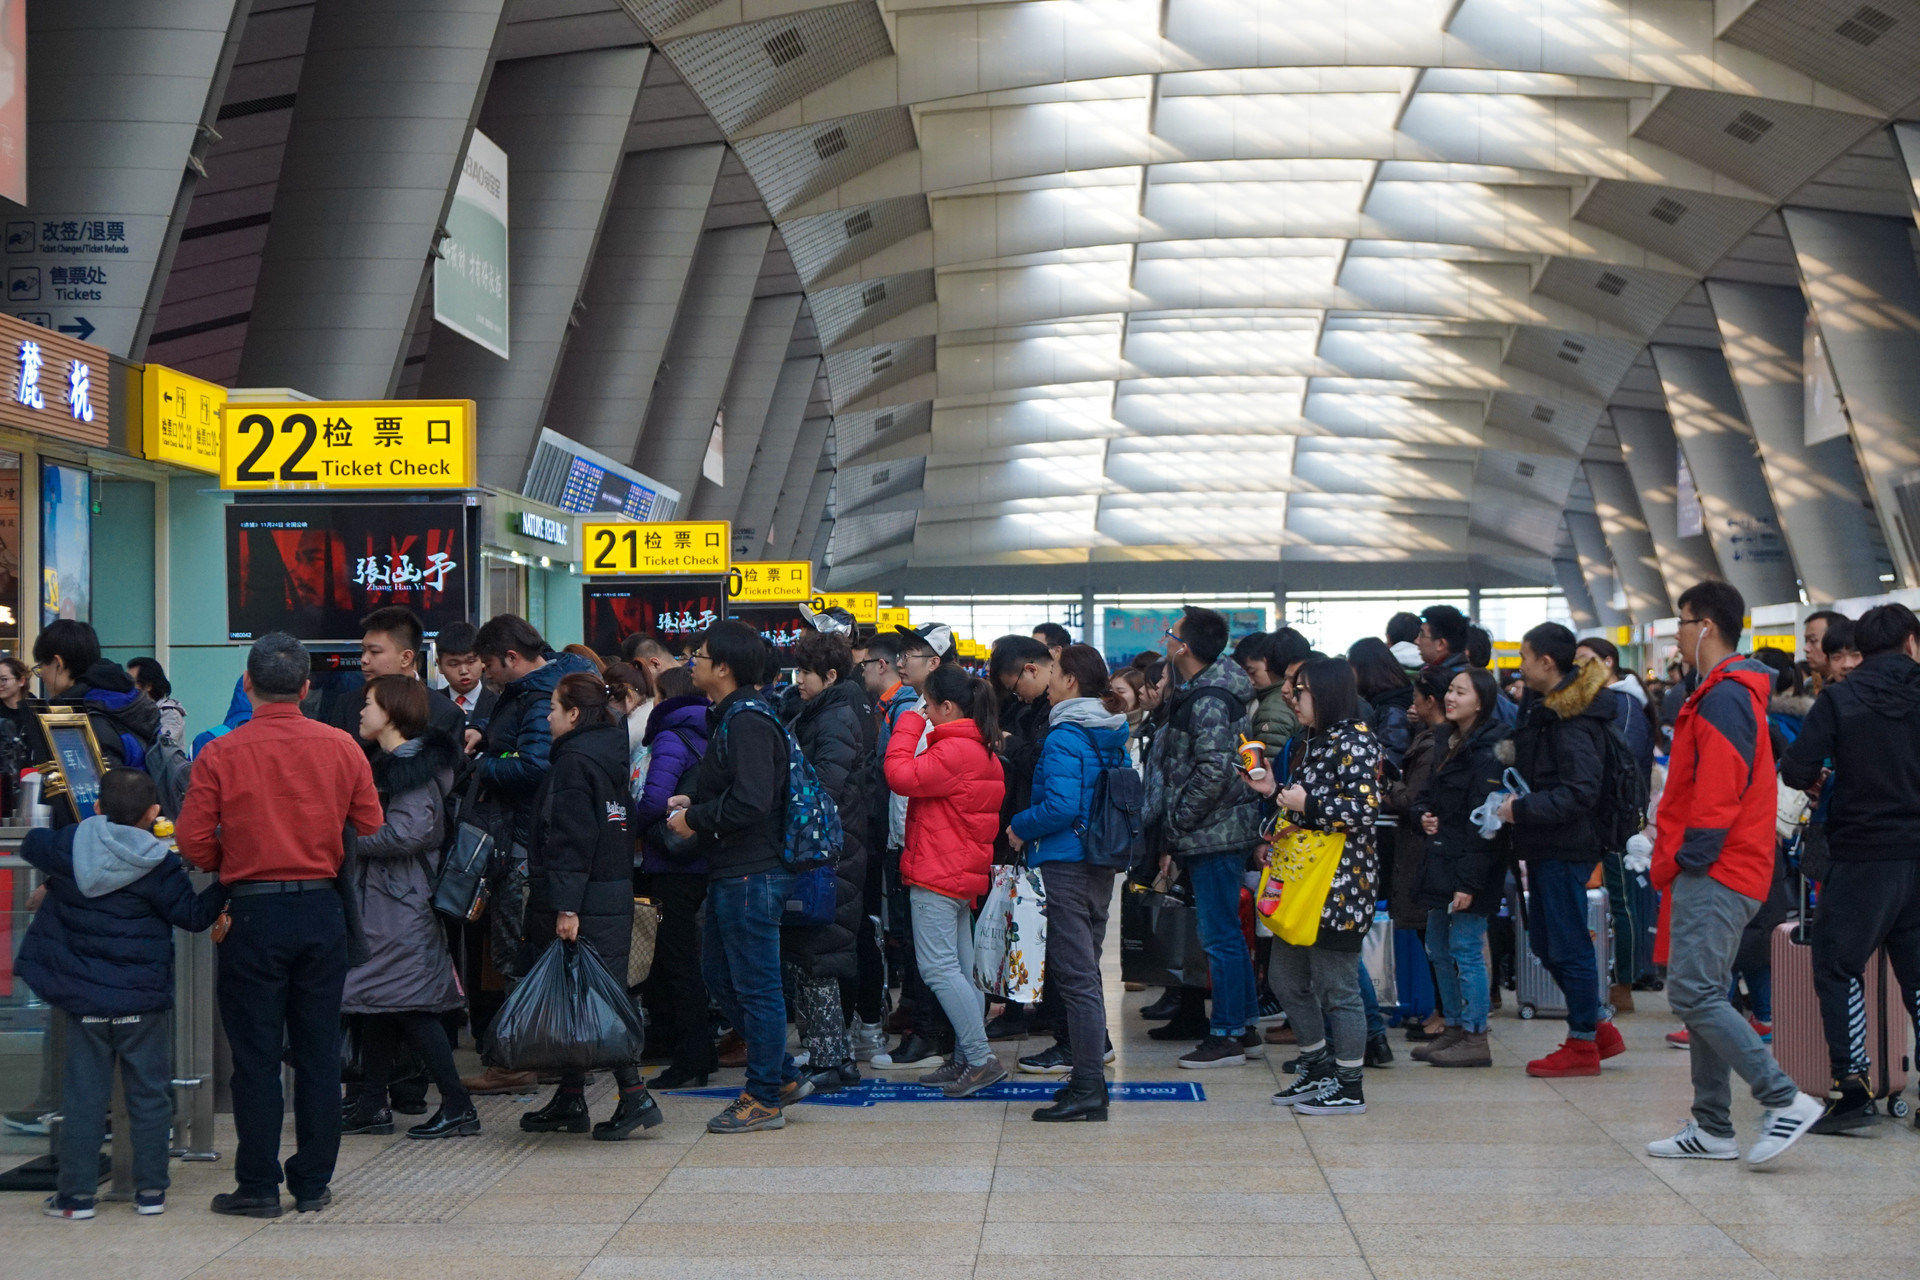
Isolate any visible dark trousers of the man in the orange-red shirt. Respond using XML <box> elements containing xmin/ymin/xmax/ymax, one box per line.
<box><xmin>217</xmin><ymin>887</ymin><xmax>348</xmax><ymax>1199</ymax></box>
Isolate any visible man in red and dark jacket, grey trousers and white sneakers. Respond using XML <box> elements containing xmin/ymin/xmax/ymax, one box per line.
<box><xmin>1647</xmin><ymin>581</ymin><xmax>1824</xmax><ymax>1165</ymax></box>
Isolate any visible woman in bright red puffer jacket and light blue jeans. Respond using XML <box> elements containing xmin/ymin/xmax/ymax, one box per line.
<box><xmin>887</xmin><ymin>666</ymin><xmax>1006</xmax><ymax>1098</ymax></box>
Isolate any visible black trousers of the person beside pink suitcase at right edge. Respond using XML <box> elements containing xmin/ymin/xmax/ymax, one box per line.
<box><xmin>1812</xmin><ymin>858</ymin><xmax>1920</xmax><ymax>1079</ymax></box>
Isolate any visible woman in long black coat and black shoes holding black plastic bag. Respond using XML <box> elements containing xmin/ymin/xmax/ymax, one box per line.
<box><xmin>520</xmin><ymin>672</ymin><xmax>660</xmax><ymax>1142</ymax></box>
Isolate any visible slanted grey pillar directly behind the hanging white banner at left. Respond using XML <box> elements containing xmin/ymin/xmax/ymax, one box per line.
<box><xmin>420</xmin><ymin>48</ymin><xmax>647</xmax><ymax>489</ymax></box>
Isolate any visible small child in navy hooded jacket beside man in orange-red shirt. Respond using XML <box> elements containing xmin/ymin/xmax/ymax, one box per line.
<box><xmin>19</xmin><ymin>770</ymin><xmax>227</xmax><ymax>1219</ymax></box>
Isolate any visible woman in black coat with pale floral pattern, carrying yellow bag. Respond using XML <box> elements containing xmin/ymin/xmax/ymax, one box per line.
<box><xmin>1256</xmin><ymin>658</ymin><xmax>1382</xmax><ymax>1115</ymax></box>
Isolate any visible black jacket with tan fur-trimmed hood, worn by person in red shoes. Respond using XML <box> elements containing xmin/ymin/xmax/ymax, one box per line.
<box><xmin>1501</xmin><ymin>662</ymin><xmax>1620</xmax><ymax>862</ymax></box>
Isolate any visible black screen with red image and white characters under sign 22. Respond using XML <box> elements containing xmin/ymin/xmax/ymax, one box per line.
<box><xmin>227</xmin><ymin>503</ymin><xmax>470</xmax><ymax>641</ymax></box>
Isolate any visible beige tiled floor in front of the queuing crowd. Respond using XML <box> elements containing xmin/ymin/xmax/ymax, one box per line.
<box><xmin>0</xmin><ymin>983</ymin><xmax>1920</xmax><ymax>1280</ymax></box>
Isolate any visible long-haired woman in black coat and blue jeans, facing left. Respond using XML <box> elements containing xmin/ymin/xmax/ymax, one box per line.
<box><xmin>1413</xmin><ymin>666</ymin><xmax>1509</xmax><ymax>1067</ymax></box>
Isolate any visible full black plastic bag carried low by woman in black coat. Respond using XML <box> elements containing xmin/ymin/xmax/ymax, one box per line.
<box><xmin>480</xmin><ymin>938</ymin><xmax>647</xmax><ymax>1071</ymax></box>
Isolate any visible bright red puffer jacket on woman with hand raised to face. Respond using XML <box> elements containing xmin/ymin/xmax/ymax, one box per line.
<box><xmin>887</xmin><ymin>712</ymin><xmax>1006</xmax><ymax>902</ymax></box>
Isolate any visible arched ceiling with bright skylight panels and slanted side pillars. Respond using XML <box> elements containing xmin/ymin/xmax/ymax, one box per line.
<box><xmin>45</xmin><ymin>0</ymin><xmax>1920</xmax><ymax>620</ymax></box>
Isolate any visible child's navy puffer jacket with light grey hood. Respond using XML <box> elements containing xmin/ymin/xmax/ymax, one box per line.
<box><xmin>17</xmin><ymin>816</ymin><xmax>227</xmax><ymax>1017</ymax></box>
